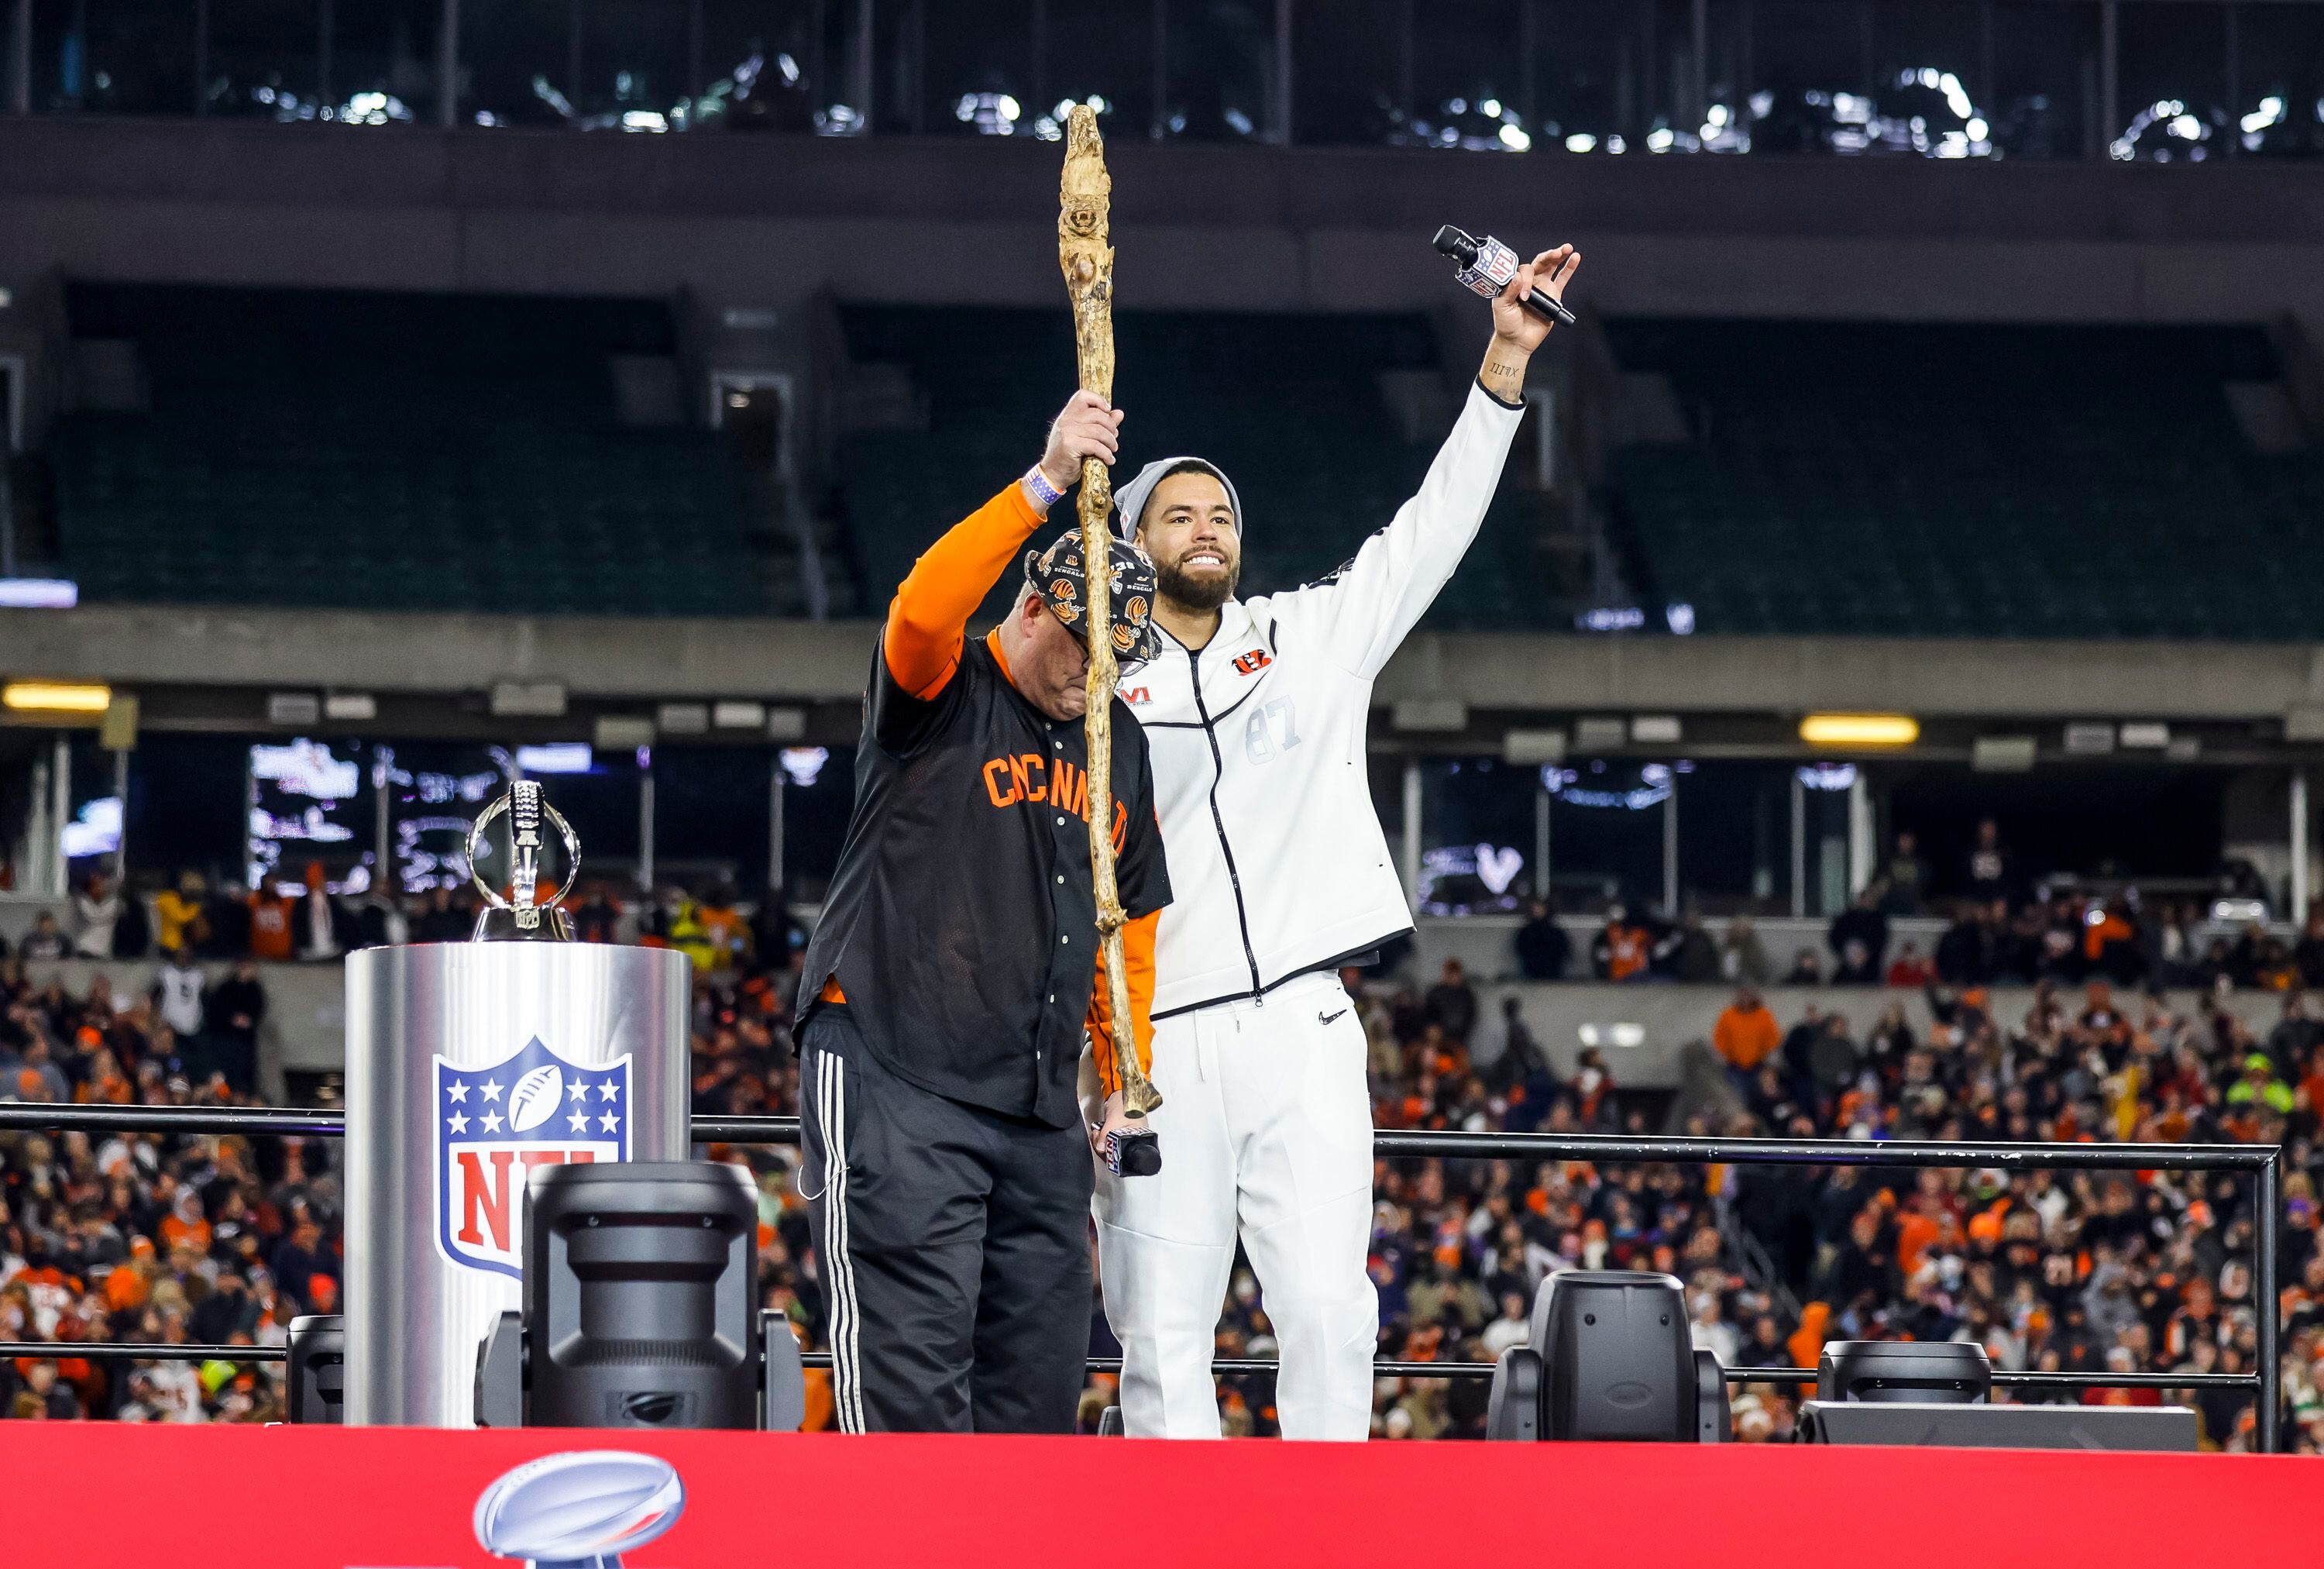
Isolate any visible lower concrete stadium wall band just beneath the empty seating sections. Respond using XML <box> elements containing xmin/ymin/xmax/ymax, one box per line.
<box><xmin>13</xmin><ymin>607</ymin><xmax>2324</xmax><ymax>737</ymax></box>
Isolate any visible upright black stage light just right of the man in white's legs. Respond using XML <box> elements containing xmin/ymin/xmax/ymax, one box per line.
<box><xmin>1485</xmin><ymin>1269</ymin><xmax>1692</xmax><ymax>1443</ymax></box>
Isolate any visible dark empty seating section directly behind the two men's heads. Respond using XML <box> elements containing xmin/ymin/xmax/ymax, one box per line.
<box><xmin>841</xmin><ymin>307</ymin><xmax>1538</xmax><ymax>625</ymax></box>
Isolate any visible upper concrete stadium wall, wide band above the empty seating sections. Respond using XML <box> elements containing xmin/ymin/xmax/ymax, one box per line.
<box><xmin>0</xmin><ymin>116</ymin><xmax>2324</xmax><ymax>321</ymax></box>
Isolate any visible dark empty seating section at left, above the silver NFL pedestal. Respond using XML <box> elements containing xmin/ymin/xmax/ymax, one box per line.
<box><xmin>53</xmin><ymin>284</ymin><xmax>765</xmax><ymax>616</ymax></box>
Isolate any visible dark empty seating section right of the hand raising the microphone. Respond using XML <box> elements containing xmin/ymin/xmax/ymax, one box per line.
<box><xmin>1608</xmin><ymin>321</ymin><xmax>2324</xmax><ymax>639</ymax></box>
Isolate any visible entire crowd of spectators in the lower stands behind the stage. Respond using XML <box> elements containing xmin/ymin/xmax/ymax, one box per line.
<box><xmin>0</xmin><ymin>846</ymin><xmax>2324</xmax><ymax>1450</ymax></box>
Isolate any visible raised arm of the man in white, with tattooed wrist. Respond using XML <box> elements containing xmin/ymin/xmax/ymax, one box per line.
<box><xmin>1276</xmin><ymin>244</ymin><xmax>1583</xmax><ymax>679</ymax></box>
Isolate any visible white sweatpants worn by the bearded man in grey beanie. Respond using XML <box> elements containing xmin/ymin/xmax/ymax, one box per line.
<box><xmin>1092</xmin><ymin>974</ymin><xmax>1380</xmax><ymax>1439</ymax></box>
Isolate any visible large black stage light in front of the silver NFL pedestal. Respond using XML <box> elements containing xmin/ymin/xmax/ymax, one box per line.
<box><xmin>525</xmin><ymin>1160</ymin><xmax>753</xmax><ymax>1427</ymax></box>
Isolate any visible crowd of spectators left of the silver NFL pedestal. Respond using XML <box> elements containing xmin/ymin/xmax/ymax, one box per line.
<box><xmin>0</xmin><ymin>960</ymin><xmax>316</xmax><ymax>1423</ymax></box>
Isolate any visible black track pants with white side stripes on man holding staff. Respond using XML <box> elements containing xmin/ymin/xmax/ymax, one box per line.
<box><xmin>799</xmin><ymin>1004</ymin><xmax>1095</xmax><ymax>1432</ymax></box>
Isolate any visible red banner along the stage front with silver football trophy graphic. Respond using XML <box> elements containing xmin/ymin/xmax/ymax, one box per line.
<box><xmin>0</xmin><ymin>1423</ymin><xmax>2324</xmax><ymax>1569</ymax></box>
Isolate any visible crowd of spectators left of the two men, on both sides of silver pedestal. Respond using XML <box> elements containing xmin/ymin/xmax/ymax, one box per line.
<box><xmin>0</xmin><ymin>874</ymin><xmax>820</xmax><ymax>1423</ymax></box>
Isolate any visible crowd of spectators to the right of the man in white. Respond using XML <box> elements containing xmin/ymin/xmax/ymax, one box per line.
<box><xmin>1311</xmin><ymin>962</ymin><xmax>2324</xmax><ymax>1453</ymax></box>
